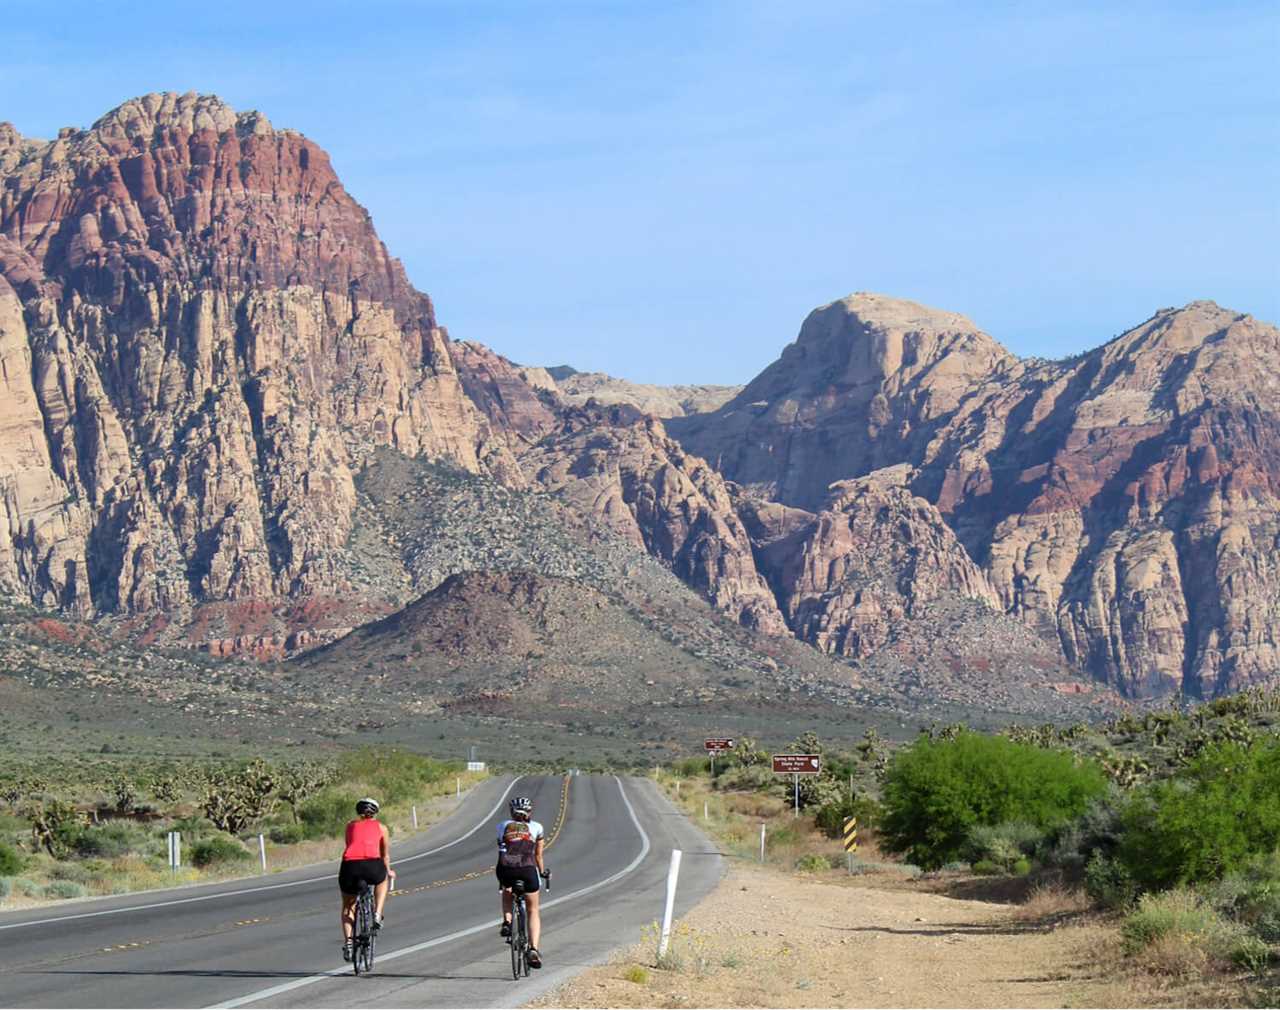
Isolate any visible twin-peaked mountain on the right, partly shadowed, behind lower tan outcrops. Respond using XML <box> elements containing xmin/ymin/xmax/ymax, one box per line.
<box><xmin>669</xmin><ymin>294</ymin><xmax>1280</xmax><ymax>695</ymax></box>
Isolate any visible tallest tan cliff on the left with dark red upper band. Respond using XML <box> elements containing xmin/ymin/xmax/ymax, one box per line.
<box><xmin>0</xmin><ymin>95</ymin><xmax>520</xmax><ymax>629</ymax></box>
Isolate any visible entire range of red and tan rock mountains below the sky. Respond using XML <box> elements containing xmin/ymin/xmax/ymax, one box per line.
<box><xmin>0</xmin><ymin>93</ymin><xmax>1280</xmax><ymax>696</ymax></box>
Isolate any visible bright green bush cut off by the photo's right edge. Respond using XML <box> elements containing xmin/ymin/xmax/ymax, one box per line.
<box><xmin>1117</xmin><ymin>739</ymin><xmax>1280</xmax><ymax>890</ymax></box>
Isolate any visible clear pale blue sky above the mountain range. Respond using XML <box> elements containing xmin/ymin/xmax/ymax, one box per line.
<box><xmin>0</xmin><ymin>0</ymin><xmax>1280</xmax><ymax>383</ymax></box>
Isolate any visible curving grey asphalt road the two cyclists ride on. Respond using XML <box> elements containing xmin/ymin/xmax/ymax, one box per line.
<box><xmin>0</xmin><ymin>776</ymin><xmax>723</xmax><ymax>1007</ymax></box>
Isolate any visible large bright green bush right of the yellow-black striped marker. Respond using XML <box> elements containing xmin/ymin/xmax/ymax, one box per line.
<box><xmin>879</xmin><ymin>732</ymin><xmax>1107</xmax><ymax>869</ymax></box>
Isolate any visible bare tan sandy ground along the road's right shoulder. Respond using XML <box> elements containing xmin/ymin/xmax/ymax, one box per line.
<box><xmin>530</xmin><ymin>863</ymin><xmax>1147</xmax><ymax>1007</ymax></box>
